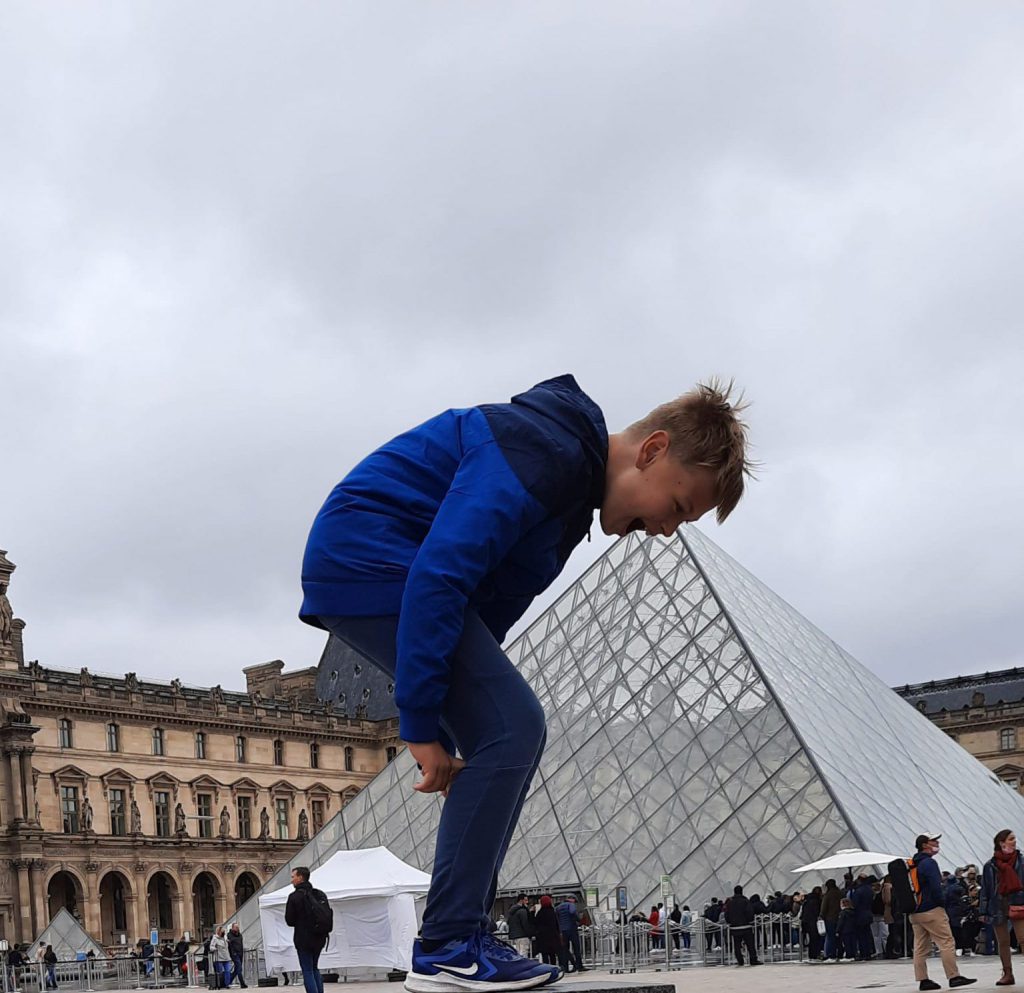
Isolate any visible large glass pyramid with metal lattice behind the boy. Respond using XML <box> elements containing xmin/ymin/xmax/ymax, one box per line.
<box><xmin>232</xmin><ymin>527</ymin><xmax>1024</xmax><ymax>943</ymax></box>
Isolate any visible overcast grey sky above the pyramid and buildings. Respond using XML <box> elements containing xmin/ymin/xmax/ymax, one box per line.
<box><xmin>0</xmin><ymin>0</ymin><xmax>1024</xmax><ymax>689</ymax></box>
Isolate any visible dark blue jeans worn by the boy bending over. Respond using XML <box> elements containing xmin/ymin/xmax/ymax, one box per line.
<box><xmin>321</xmin><ymin>610</ymin><xmax>546</xmax><ymax>941</ymax></box>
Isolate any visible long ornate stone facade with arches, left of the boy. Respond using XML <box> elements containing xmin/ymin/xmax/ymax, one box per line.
<box><xmin>0</xmin><ymin>552</ymin><xmax>398</xmax><ymax>946</ymax></box>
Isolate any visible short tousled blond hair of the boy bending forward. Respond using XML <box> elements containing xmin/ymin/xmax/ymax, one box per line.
<box><xmin>627</xmin><ymin>378</ymin><xmax>755</xmax><ymax>524</ymax></box>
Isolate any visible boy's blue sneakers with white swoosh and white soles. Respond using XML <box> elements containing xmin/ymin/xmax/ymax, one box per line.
<box><xmin>406</xmin><ymin>934</ymin><xmax>561</xmax><ymax>993</ymax></box>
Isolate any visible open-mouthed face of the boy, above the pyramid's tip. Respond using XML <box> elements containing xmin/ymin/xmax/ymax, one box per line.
<box><xmin>601</xmin><ymin>431</ymin><xmax>717</xmax><ymax>536</ymax></box>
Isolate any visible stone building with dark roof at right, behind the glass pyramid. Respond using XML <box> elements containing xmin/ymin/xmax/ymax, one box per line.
<box><xmin>895</xmin><ymin>667</ymin><xmax>1024</xmax><ymax>790</ymax></box>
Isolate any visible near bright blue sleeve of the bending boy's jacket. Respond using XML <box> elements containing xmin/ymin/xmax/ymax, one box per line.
<box><xmin>395</xmin><ymin>440</ymin><xmax>547</xmax><ymax>742</ymax></box>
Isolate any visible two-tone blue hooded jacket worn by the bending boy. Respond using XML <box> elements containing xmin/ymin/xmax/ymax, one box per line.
<box><xmin>299</xmin><ymin>376</ymin><xmax>608</xmax><ymax>742</ymax></box>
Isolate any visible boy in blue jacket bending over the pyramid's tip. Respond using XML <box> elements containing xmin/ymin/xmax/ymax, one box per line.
<box><xmin>300</xmin><ymin>368</ymin><xmax>749</xmax><ymax>993</ymax></box>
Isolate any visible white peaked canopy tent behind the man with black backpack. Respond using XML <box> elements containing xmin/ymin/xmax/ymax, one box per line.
<box><xmin>259</xmin><ymin>848</ymin><xmax>430</xmax><ymax>974</ymax></box>
